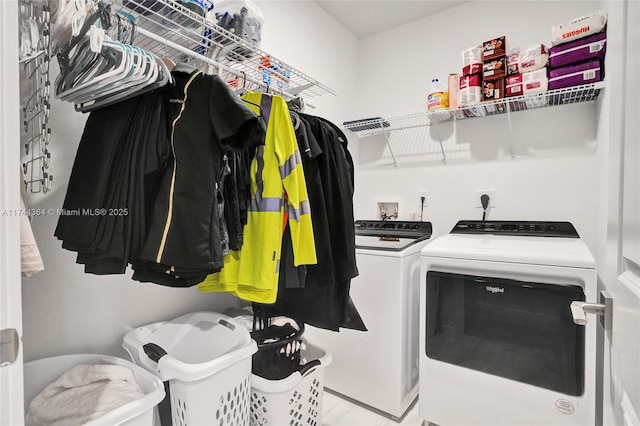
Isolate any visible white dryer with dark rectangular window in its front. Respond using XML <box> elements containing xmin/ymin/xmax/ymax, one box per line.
<box><xmin>419</xmin><ymin>221</ymin><xmax>598</xmax><ymax>426</ymax></box>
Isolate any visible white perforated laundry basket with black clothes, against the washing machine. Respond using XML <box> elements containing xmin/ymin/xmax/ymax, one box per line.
<box><xmin>250</xmin><ymin>339</ymin><xmax>331</xmax><ymax>426</ymax></box>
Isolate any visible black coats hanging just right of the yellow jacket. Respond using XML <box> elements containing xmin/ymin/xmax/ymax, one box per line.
<box><xmin>269</xmin><ymin>114</ymin><xmax>366</xmax><ymax>331</ymax></box>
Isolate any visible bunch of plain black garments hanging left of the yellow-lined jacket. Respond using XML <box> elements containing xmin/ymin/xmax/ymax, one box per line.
<box><xmin>54</xmin><ymin>89</ymin><xmax>170</xmax><ymax>274</ymax></box>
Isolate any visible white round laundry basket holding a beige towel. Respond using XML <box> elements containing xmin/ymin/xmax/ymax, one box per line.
<box><xmin>24</xmin><ymin>354</ymin><xmax>164</xmax><ymax>426</ymax></box>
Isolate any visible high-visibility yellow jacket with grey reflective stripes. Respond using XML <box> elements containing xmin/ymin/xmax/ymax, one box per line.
<box><xmin>199</xmin><ymin>92</ymin><xmax>317</xmax><ymax>303</ymax></box>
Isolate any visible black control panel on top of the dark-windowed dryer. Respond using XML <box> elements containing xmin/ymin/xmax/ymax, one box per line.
<box><xmin>451</xmin><ymin>220</ymin><xmax>580</xmax><ymax>238</ymax></box>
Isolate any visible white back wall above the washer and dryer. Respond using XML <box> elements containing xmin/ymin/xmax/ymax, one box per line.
<box><xmin>352</xmin><ymin>1</ymin><xmax>607</xmax><ymax>251</ymax></box>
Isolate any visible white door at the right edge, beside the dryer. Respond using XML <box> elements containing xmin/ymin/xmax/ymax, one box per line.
<box><xmin>599</xmin><ymin>0</ymin><xmax>640</xmax><ymax>426</ymax></box>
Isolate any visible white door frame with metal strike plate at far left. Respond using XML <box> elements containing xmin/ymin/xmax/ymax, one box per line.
<box><xmin>0</xmin><ymin>0</ymin><xmax>24</xmax><ymax>425</ymax></box>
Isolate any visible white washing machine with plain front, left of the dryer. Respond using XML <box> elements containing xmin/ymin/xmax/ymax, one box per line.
<box><xmin>305</xmin><ymin>220</ymin><xmax>432</xmax><ymax>419</ymax></box>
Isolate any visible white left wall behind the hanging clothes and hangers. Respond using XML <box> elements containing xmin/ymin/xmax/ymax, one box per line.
<box><xmin>22</xmin><ymin>1</ymin><xmax>357</xmax><ymax>361</ymax></box>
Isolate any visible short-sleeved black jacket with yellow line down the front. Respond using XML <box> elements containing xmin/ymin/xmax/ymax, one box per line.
<box><xmin>133</xmin><ymin>64</ymin><xmax>258</xmax><ymax>286</ymax></box>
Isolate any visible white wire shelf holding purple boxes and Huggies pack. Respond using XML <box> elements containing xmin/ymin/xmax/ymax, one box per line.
<box><xmin>343</xmin><ymin>81</ymin><xmax>605</xmax><ymax>137</ymax></box>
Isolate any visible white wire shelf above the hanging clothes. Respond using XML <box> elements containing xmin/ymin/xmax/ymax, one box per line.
<box><xmin>104</xmin><ymin>0</ymin><xmax>336</xmax><ymax>98</ymax></box>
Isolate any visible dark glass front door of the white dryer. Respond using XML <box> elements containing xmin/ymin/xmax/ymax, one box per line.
<box><xmin>425</xmin><ymin>271</ymin><xmax>585</xmax><ymax>396</ymax></box>
